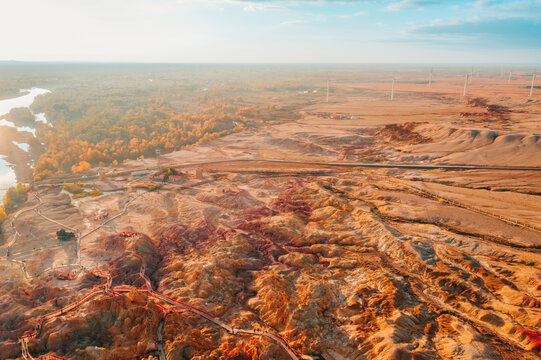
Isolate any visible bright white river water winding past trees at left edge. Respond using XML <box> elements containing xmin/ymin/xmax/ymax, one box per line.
<box><xmin>0</xmin><ymin>88</ymin><xmax>50</xmax><ymax>201</ymax></box>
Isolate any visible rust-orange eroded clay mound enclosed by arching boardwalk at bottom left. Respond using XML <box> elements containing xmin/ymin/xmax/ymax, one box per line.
<box><xmin>36</xmin><ymin>292</ymin><xmax>162</xmax><ymax>360</ymax></box>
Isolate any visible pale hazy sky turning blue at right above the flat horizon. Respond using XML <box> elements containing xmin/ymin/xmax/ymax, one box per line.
<box><xmin>0</xmin><ymin>0</ymin><xmax>541</xmax><ymax>64</ymax></box>
